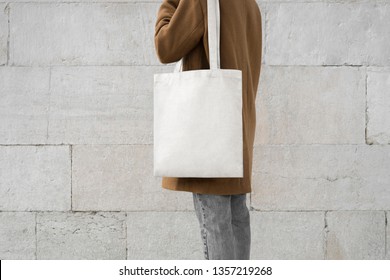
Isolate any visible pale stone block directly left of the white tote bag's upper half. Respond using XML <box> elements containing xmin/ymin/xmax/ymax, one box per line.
<box><xmin>48</xmin><ymin>66</ymin><xmax>172</xmax><ymax>144</ymax></box>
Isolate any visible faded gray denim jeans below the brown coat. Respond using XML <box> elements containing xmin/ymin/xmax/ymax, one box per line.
<box><xmin>193</xmin><ymin>193</ymin><xmax>251</xmax><ymax>260</ymax></box>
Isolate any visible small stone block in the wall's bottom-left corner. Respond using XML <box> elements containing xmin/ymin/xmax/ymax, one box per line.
<box><xmin>0</xmin><ymin>212</ymin><xmax>36</xmax><ymax>260</ymax></box>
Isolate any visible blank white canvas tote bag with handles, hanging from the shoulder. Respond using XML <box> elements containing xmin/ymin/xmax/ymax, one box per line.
<box><xmin>153</xmin><ymin>0</ymin><xmax>243</xmax><ymax>177</ymax></box>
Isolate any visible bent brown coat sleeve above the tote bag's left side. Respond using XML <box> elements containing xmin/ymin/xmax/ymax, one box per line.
<box><xmin>154</xmin><ymin>0</ymin><xmax>204</xmax><ymax>63</ymax></box>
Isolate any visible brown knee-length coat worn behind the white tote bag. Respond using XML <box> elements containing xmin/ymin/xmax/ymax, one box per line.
<box><xmin>154</xmin><ymin>0</ymin><xmax>262</xmax><ymax>195</ymax></box>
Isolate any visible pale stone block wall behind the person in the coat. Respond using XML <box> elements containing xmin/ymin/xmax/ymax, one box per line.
<box><xmin>0</xmin><ymin>0</ymin><xmax>390</xmax><ymax>259</ymax></box>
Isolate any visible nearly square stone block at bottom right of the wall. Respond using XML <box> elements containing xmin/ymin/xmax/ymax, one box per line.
<box><xmin>326</xmin><ymin>211</ymin><xmax>386</xmax><ymax>260</ymax></box>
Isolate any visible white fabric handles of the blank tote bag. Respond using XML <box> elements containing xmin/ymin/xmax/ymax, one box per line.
<box><xmin>174</xmin><ymin>0</ymin><xmax>221</xmax><ymax>73</ymax></box>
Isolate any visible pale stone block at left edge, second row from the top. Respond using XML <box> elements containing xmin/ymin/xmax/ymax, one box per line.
<box><xmin>0</xmin><ymin>66</ymin><xmax>50</xmax><ymax>144</ymax></box>
